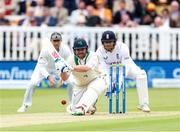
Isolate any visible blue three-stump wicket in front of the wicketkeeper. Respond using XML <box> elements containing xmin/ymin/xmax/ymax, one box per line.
<box><xmin>107</xmin><ymin>64</ymin><xmax>126</xmax><ymax>114</ymax></box>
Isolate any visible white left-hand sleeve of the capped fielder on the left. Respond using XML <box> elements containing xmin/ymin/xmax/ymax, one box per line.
<box><xmin>38</xmin><ymin>50</ymin><xmax>50</xmax><ymax>78</ymax></box>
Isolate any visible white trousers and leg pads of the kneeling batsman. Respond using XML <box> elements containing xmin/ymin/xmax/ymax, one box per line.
<box><xmin>70</xmin><ymin>77</ymin><xmax>107</xmax><ymax>112</ymax></box>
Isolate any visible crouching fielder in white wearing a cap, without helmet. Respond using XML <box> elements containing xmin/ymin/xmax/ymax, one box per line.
<box><xmin>17</xmin><ymin>32</ymin><xmax>71</xmax><ymax>112</ymax></box>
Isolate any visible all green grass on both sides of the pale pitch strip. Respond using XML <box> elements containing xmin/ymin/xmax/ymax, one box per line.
<box><xmin>0</xmin><ymin>88</ymin><xmax>180</xmax><ymax>131</ymax></box>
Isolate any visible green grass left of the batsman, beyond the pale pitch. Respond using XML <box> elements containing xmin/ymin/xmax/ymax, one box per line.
<box><xmin>0</xmin><ymin>89</ymin><xmax>67</xmax><ymax>114</ymax></box>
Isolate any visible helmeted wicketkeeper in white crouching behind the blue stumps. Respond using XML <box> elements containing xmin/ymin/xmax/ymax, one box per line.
<box><xmin>96</xmin><ymin>31</ymin><xmax>150</xmax><ymax>112</ymax></box>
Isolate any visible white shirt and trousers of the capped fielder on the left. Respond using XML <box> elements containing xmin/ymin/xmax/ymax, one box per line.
<box><xmin>23</xmin><ymin>43</ymin><xmax>71</xmax><ymax>106</ymax></box>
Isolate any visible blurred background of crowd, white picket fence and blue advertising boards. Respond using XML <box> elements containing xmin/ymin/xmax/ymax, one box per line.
<box><xmin>0</xmin><ymin>0</ymin><xmax>180</xmax><ymax>89</ymax></box>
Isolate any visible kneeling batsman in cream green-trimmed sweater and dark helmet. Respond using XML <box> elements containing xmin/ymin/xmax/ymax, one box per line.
<box><xmin>67</xmin><ymin>39</ymin><xmax>107</xmax><ymax>115</ymax></box>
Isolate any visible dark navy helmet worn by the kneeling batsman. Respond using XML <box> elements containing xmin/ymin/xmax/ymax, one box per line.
<box><xmin>73</xmin><ymin>38</ymin><xmax>88</xmax><ymax>50</ymax></box>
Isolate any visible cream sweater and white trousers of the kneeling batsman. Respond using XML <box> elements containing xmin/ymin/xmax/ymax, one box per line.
<box><xmin>68</xmin><ymin>52</ymin><xmax>107</xmax><ymax>112</ymax></box>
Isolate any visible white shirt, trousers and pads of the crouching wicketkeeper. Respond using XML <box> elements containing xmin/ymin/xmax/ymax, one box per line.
<box><xmin>96</xmin><ymin>42</ymin><xmax>149</xmax><ymax>105</ymax></box>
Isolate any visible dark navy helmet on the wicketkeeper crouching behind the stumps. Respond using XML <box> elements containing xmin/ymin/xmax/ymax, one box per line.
<box><xmin>101</xmin><ymin>30</ymin><xmax>117</xmax><ymax>44</ymax></box>
